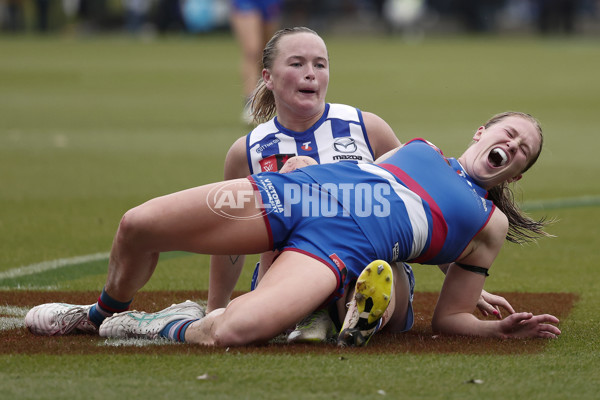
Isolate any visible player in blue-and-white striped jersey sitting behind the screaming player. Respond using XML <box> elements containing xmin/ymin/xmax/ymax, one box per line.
<box><xmin>207</xmin><ymin>27</ymin><xmax>412</xmax><ymax>340</ymax></box>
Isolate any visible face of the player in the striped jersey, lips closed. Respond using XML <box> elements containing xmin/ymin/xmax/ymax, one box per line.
<box><xmin>263</xmin><ymin>32</ymin><xmax>329</xmax><ymax>118</ymax></box>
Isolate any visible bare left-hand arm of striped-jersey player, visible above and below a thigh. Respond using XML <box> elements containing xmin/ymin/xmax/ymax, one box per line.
<box><xmin>206</xmin><ymin>136</ymin><xmax>250</xmax><ymax>312</ymax></box>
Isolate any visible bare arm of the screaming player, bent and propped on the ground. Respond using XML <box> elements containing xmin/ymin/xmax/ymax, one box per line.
<box><xmin>432</xmin><ymin>210</ymin><xmax>560</xmax><ymax>338</ymax></box>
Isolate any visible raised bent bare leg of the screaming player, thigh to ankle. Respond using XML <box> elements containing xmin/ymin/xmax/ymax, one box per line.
<box><xmin>105</xmin><ymin>179</ymin><xmax>269</xmax><ymax>302</ymax></box>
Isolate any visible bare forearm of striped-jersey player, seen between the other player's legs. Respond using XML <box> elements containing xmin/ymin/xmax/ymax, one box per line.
<box><xmin>206</xmin><ymin>255</ymin><xmax>246</xmax><ymax>312</ymax></box>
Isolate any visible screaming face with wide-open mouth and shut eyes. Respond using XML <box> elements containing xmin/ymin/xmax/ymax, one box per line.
<box><xmin>459</xmin><ymin>116</ymin><xmax>541</xmax><ymax>189</ymax></box>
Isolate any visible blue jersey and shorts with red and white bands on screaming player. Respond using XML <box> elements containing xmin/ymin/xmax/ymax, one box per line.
<box><xmin>249</xmin><ymin>139</ymin><xmax>494</xmax><ymax>283</ymax></box>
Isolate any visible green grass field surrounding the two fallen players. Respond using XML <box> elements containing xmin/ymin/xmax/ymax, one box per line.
<box><xmin>0</xmin><ymin>32</ymin><xmax>600</xmax><ymax>400</ymax></box>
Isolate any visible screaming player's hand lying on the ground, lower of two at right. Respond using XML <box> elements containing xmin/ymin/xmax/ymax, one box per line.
<box><xmin>500</xmin><ymin>312</ymin><xmax>561</xmax><ymax>339</ymax></box>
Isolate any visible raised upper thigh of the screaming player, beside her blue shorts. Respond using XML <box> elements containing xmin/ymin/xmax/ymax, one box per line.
<box><xmin>126</xmin><ymin>178</ymin><xmax>270</xmax><ymax>254</ymax></box>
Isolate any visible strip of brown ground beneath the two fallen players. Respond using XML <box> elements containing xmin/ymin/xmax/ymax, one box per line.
<box><xmin>0</xmin><ymin>291</ymin><xmax>578</xmax><ymax>357</ymax></box>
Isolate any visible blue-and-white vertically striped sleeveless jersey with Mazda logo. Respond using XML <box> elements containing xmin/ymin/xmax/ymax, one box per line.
<box><xmin>246</xmin><ymin>103</ymin><xmax>374</xmax><ymax>174</ymax></box>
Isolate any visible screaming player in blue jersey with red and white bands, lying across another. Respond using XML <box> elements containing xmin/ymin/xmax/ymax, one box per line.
<box><xmin>25</xmin><ymin>113</ymin><xmax>561</xmax><ymax>346</ymax></box>
